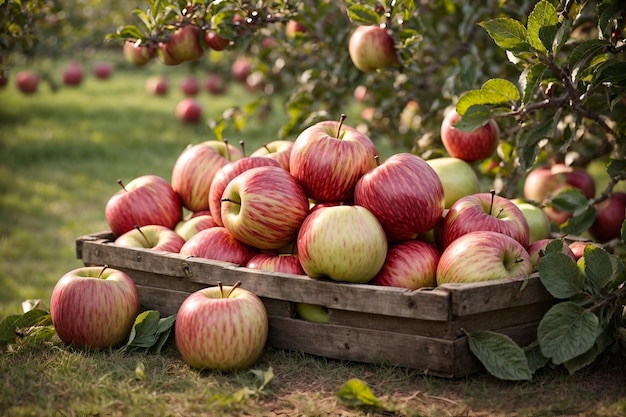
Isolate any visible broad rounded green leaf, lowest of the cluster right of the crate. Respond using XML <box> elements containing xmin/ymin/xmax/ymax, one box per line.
<box><xmin>537</xmin><ymin>301</ymin><xmax>598</xmax><ymax>365</ymax></box>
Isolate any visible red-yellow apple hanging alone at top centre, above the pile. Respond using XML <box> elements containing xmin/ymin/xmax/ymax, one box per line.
<box><xmin>348</xmin><ymin>25</ymin><xmax>398</xmax><ymax>72</ymax></box>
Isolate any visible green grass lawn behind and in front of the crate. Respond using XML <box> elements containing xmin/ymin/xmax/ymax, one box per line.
<box><xmin>0</xmin><ymin>57</ymin><xmax>626</xmax><ymax>416</ymax></box>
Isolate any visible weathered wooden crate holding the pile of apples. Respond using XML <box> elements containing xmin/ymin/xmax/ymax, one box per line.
<box><xmin>76</xmin><ymin>232</ymin><xmax>554</xmax><ymax>378</ymax></box>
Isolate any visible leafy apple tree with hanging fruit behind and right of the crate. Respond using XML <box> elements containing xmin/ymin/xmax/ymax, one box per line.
<box><xmin>108</xmin><ymin>0</ymin><xmax>626</xmax><ymax>379</ymax></box>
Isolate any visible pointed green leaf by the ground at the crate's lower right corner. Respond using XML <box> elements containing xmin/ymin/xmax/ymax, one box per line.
<box><xmin>467</xmin><ymin>331</ymin><xmax>532</xmax><ymax>381</ymax></box>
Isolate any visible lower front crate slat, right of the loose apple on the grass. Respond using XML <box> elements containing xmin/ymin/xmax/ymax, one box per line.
<box><xmin>267</xmin><ymin>317</ymin><xmax>454</xmax><ymax>377</ymax></box>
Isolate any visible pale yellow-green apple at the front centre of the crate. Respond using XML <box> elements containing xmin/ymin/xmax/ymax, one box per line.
<box><xmin>297</xmin><ymin>205</ymin><xmax>387</xmax><ymax>283</ymax></box>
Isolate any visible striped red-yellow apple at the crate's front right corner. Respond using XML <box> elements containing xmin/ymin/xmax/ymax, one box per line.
<box><xmin>437</xmin><ymin>230</ymin><xmax>533</xmax><ymax>285</ymax></box>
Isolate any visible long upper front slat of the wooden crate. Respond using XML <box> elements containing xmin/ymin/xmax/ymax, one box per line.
<box><xmin>82</xmin><ymin>236</ymin><xmax>450</xmax><ymax>321</ymax></box>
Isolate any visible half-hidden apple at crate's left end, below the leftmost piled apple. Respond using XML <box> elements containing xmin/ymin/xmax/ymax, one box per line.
<box><xmin>113</xmin><ymin>224</ymin><xmax>185</xmax><ymax>253</ymax></box>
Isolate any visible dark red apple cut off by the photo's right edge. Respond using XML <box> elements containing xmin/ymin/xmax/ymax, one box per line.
<box><xmin>589</xmin><ymin>192</ymin><xmax>626</xmax><ymax>242</ymax></box>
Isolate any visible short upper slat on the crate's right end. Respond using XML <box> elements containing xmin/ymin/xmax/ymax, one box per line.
<box><xmin>439</xmin><ymin>274</ymin><xmax>554</xmax><ymax>317</ymax></box>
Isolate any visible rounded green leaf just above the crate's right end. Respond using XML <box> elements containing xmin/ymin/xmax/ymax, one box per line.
<box><xmin>539</xmin><ymin>252</ymin><xmax>584</xmax><ymax>299</ymax></box>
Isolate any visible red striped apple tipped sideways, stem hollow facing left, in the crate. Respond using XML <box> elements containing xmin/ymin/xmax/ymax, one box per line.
<box><xmin>220</xmin><ymin>166</ymin><xmax>309</xmax><ymax>249</ymax></box>
